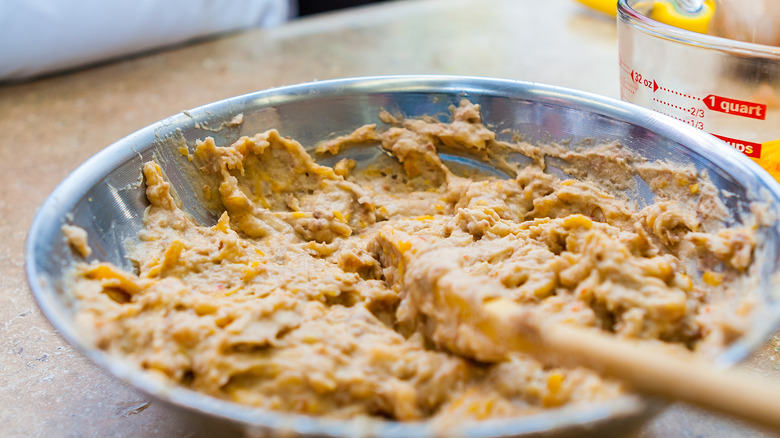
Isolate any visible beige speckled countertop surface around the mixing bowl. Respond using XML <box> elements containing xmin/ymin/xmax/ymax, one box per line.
<box><xmin>0</xmin><ymin>0</ymin><xmax>780</xmax><ymax>437</ymax></box>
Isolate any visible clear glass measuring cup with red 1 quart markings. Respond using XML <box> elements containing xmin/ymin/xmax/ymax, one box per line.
<box><xmin>617</xmin><ymin>0</ymin><xmax>780</xmax><ymax>180</ymax></box>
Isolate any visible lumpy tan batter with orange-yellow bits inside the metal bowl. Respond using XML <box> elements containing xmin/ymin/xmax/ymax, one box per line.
<box><xmin>71</xmin><ymin>101</ymin><xmax>756</xmax><ymax>422</ymax></box>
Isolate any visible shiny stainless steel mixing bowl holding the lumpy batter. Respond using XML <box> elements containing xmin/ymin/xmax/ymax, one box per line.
<box><xmin>26</xmin><ymin>76</ymin><xmax>780</xmax><ymax>437</ymax></box>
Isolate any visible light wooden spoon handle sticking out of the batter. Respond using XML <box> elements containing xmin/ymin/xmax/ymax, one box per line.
<box><xmin>484</xmin><ymin>300</ymin><xmax>780</xmax><ymax>431</ymax></box>
